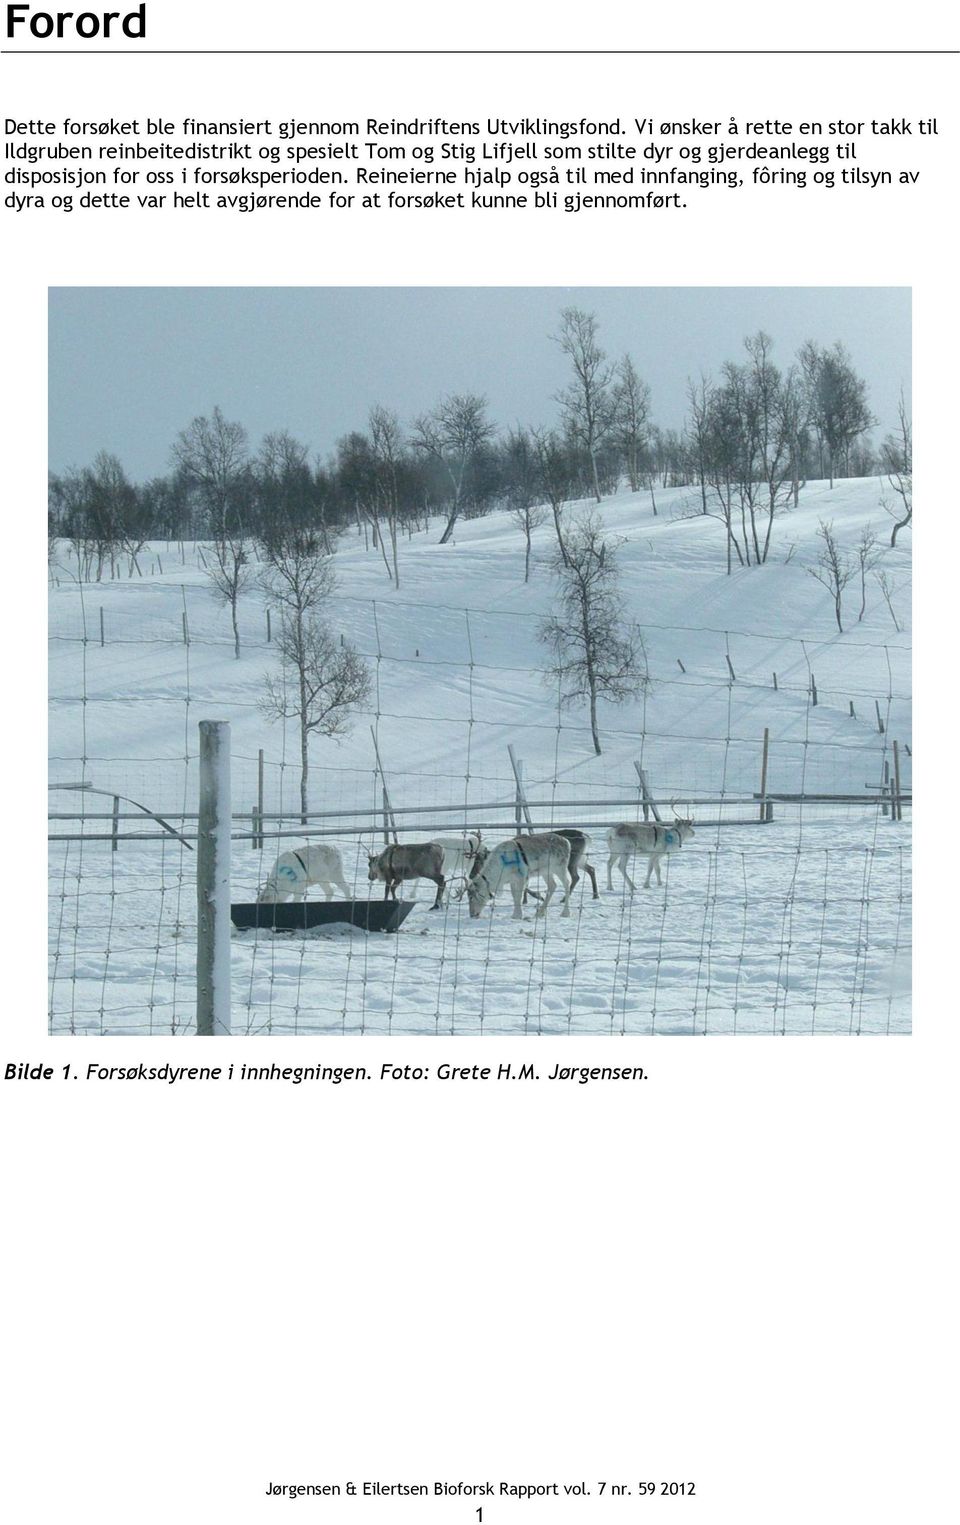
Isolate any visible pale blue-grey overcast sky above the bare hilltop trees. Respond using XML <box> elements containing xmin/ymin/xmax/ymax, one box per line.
<box><xmin>49</xmin><ymin>287</ymin><xmax>911</xmax><ymax>480</ymax></box>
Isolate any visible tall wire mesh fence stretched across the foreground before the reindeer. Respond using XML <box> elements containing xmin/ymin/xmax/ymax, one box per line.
<box><xmin>49</xmin><ymin>549</ymin><xmax>911</xmax><ymax>1034</ymax></box>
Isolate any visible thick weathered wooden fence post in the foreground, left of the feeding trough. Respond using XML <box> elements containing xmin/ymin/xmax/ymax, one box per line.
<box><xmin>197</xmin><ymin>720</ymin><xmax>230</xmax><ymax>1037</ymax></box>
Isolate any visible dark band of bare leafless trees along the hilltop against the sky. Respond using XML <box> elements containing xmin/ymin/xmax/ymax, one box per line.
<box><xmin>49</xmin><ymin>308</ymin><xmax>910</xmax><ymax>591</ymax></box>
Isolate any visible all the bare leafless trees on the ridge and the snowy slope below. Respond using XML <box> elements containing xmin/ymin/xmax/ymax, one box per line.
<box><xmin>49</xmin><ymin>307</ymin><xmax>913</xmax><ymax>768</ymax></box>
